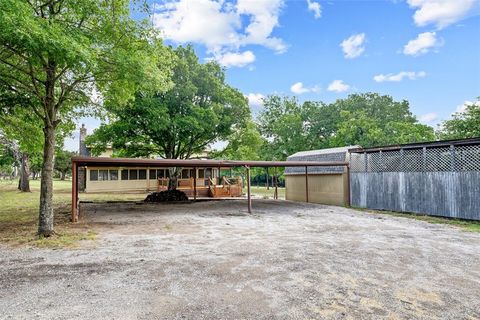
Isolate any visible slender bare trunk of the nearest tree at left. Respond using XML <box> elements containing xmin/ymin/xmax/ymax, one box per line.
<box><xmin>38</xmin><ymin>125</ymin><xmax>55</xmax><ymax>237</ymax></box>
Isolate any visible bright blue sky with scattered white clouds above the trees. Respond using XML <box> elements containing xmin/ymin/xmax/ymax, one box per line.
<box><xmin>66</xmin><ymin>0</ymin><xmax>480</xmax><ymax>150</ymax></box>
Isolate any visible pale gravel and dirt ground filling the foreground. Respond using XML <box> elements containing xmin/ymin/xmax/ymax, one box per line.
<box><xmin>0</xmin><ymin>200</ymin><xmax>480</xmax><ymax>319</ymax></box>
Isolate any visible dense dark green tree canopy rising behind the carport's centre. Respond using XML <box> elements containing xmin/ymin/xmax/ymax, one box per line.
<box><xmin>87</xmin><ymin>46</ymin><xmax>250</xmax><ymax>159</ymax></box>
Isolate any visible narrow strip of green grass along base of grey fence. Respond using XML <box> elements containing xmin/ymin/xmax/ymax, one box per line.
<box><xmin>360</xmin><ymin>208</ymin><xmax>480</xmax><ymax>233</ymax></box>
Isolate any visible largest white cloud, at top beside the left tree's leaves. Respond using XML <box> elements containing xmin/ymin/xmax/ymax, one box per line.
<box><xmin>152</xmin><ymin>0</ymin><xmax>287</xmax><ymax>67</ymax></box>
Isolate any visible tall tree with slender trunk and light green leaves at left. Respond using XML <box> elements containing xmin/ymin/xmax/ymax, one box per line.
<box><xmin>0</xmin><ymin>0</ymin><xmax>170</xmax><ymax>236</ymax></box>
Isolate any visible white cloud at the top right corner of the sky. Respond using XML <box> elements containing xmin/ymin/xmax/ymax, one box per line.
<box><xmin>408</xmin><ymin>0</ymin><xmax>476</xmax><ymax>29</ymax></box>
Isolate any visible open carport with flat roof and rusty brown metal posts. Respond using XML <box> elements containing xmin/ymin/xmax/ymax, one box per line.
<box><xmin>72</xmin><ymin>156</ymin><xmax>349</xmax><ymax>222</ymax></box>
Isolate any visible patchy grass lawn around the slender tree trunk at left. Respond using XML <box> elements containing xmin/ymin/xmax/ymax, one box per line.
<box><xmin>0</xmin><ymin>180</ymin><xmax>145</xmax><ymax>247</ymax></box>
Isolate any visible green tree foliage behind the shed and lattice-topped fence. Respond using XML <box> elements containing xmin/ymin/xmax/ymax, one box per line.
<box><xmin>259</xmin><ymin>93</ymin><xmax>435</xmax><ymax>160</ymax></box>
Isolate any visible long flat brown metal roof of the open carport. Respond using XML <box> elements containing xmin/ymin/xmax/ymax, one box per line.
<box><xmin>72</xmin><ymin>157</ymin><xmax>348</xmax><ymax>168</ymax></box>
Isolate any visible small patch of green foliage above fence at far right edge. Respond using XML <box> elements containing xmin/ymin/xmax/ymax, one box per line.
<box><xmin>437</xmin><ymin>98</ymin><xmax>480</xmax><ymax>139</ymax></box>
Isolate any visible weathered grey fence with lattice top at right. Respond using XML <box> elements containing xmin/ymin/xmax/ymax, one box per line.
<box><xmin>350</xmin><ymin>139</ymin><xmax>480</xmax><ymax>220</ymax></box>
